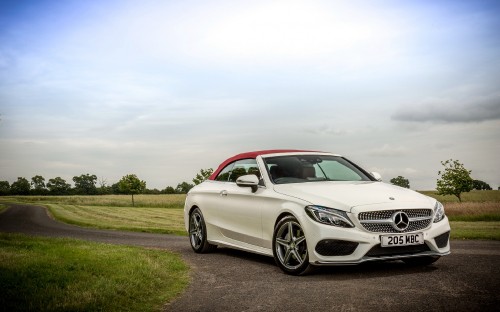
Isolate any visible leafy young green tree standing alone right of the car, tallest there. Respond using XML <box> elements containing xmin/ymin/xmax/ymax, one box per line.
<box><xmin>437</xmin><ymin>159</ymin><xmax>474</xmax><ymax>202</ymax></box>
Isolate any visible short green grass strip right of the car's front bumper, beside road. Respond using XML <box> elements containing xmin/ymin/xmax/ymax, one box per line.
<box><xmin>450</xmin><ymin>221</ymin><xmax>500</xmax><ymax>240</ymax></box>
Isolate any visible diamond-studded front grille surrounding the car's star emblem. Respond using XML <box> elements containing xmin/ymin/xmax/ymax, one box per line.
<box><xmin>358</xmin><ymin>209</ymin><xmax>432</xmax><ymax>233</ymax></box>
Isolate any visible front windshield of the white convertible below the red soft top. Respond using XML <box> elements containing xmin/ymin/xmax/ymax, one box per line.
<box><xmin>264</xmin><ymin>155</ymin><xmax>371</xmax><ymax>184</ymax></box>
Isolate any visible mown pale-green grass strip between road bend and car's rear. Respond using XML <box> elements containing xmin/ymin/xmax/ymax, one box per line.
<box><xmin>45</xmin><ymin>204</ymin><xmax>187</xmax><ymax>235</ymax></box>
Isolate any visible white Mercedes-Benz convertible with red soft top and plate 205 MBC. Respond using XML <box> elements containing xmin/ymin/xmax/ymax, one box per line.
<box><xmin>184</xmin><ymin>150</ymin><xmax>450</xmax><ymax>275</ymax></box>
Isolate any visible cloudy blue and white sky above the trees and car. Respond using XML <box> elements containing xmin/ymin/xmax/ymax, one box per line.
<box><xmin>0</xmin><ymin>0</ymin><xmax>500</xmax><ymax>190</ymax></box>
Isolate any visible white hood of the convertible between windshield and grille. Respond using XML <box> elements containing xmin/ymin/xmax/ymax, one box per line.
<box><xmin>274</xmin><ymin>181</ymin><xmax>433</xmax><ymax>211</ymax></box>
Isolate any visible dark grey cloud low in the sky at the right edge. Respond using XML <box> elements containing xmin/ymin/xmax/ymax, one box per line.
<box><xmin>392</xmin><ymin>93</ymin><xmax>500</xmax><ymax>123</ymax></box>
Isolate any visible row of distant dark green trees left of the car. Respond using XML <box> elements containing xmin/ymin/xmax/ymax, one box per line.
<box><xmin>0</xmin><ymin>169</ymin><xmax>213</xmax><ymax>196</ymax></box>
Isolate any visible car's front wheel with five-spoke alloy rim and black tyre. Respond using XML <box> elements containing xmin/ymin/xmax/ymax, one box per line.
<box><xmin>273</xmin><ymin>216</ymin><xmax>311</xmax><ymax>275</ymax></box>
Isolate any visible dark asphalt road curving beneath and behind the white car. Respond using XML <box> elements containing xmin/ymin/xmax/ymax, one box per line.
<box><xmin>0</xmin><ymin>205</ymin><xmax>500</xmax><ymax>312</ymax></box>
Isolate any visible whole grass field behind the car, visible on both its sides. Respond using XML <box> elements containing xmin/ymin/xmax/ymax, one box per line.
<box><xmin>0</xmin><ymin>191</ymin><xmax>500</xmax><ymax>240</ymax></box>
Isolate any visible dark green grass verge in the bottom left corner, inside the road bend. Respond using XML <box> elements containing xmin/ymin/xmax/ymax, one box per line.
<box><xmin>0</xmin><ymin>234</ymin><xmax>189</xmax><ymax>311</ymax></box>
